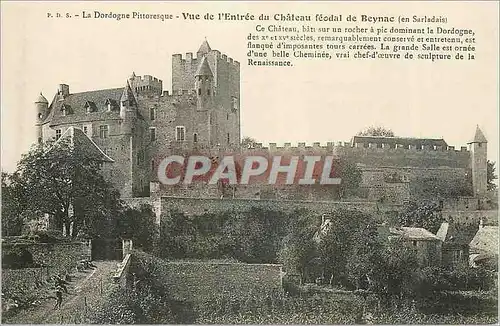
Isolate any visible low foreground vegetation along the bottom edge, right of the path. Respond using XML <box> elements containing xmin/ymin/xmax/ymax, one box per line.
<box><xmin>87</xmin><ymin>251</ymin><xmax>497</xmax><ymax>325</ymax></box>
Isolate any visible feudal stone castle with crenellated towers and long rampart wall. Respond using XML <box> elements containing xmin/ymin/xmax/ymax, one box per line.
<box><xmin>35</xmin><ymin>40</ymin><xmax>487</xmax><ymax>205</ymax></box>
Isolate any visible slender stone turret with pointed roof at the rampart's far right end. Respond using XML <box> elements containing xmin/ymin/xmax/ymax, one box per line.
<box><xmin>469</xmin><ymin>126</ymin><xmax>488</xmax><ymax>197</ymax></box>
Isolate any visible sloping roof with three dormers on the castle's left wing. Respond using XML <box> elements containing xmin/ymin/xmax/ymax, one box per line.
<box><xmin>45</xmin><ymin>87</ymin><xmax>124</xmax><ymax>127</ymax></box>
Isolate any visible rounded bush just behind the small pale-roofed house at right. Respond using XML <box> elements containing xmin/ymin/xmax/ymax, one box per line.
<box><xmin>398</xmin><ymin>201</ymin><xmax>444</xmax><ymax>234</ymax></box>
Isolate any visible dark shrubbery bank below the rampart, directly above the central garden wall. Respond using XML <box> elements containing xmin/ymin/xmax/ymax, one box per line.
<box><xmin>158</xmin><ymin>208</ymin><xmax>293</xmax><ymax>263</ymax></box>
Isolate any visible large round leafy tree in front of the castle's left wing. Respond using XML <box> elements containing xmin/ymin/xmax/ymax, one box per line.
<box><xmin>11</xmin><ymin>140</ymin><xmax>122</xmax><ymax>236</ymax></box>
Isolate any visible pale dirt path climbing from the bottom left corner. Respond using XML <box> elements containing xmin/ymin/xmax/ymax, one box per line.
<box><xmin>3</xmin><ymin>261</ymin><xmax>119</xmax><ymax>324</ymax></box>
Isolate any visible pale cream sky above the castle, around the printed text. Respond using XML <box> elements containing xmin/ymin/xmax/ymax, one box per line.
<box><xmin>1</xmin><ymin>2</ymin><xmax>499</xmax><ymax>171</ymax></box>
